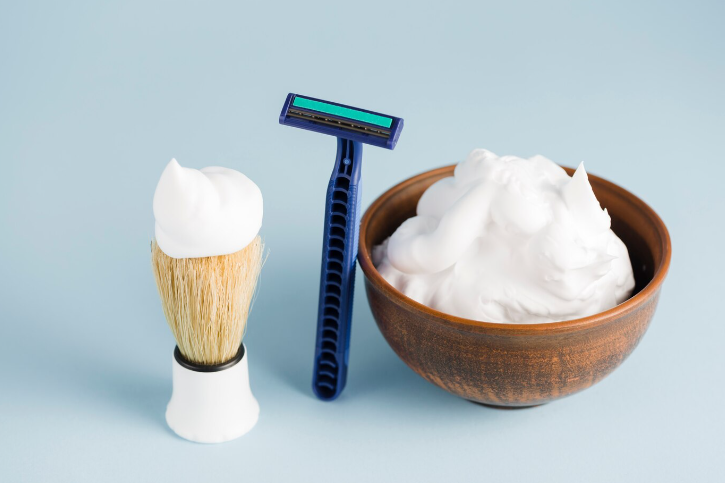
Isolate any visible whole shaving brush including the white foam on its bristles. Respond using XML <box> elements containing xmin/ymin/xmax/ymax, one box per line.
<box><xmin>151</xmin><ymin>159</ymin><xmax>263</xmax><ymax>443</ymax></box>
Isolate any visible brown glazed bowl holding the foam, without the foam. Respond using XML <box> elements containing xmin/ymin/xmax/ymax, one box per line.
<box><xmin>358</xmin><ymin>166</ymin><xmax>672</xmax><ymax>407</ymax></box>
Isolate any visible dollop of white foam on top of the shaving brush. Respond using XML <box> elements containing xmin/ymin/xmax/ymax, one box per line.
<box><xmin>154</xmin><ymin>159</ymin><xmax>263</xmax><ymax>258</ymax></box>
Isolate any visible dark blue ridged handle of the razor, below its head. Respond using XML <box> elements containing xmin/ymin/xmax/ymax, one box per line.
<box><xmin>312</xmin><ymin>138</ymin><xmax>362</xmax><ymax>401</ymax></box>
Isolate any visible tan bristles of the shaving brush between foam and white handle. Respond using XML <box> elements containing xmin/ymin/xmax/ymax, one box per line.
<box><xmin>151</xmin><ymin>236</ymin><xmax>263</xmax><ymax>365</ymax></box>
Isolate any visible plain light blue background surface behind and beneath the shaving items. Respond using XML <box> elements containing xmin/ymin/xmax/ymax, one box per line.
<box><xmin>0</xmin><ymin>1</ymin><xmax>725</xmax><ymax>482</ymax></box>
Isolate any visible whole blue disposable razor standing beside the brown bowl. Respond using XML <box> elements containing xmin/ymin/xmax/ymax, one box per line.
<box><xmin>279</xmin><ymin>94</ymin><xmax>403</xmax><ymax>401</ymax></box>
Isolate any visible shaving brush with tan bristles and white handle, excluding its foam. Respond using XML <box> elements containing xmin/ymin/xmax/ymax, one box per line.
<box><xmin>151</xmin><ymin>236</ymin><xmax>263</xmax><ymax>443</ymax></box>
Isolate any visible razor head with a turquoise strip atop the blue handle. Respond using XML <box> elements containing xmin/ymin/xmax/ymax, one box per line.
<box><xmin>279</xmin><ymin>93</ymin><xmax>403</xmax><ymax>149</ymax></box>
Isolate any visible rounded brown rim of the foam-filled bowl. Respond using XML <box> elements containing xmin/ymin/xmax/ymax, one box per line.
<box><xmin>358</xmin><ymin>164</ymin><xmax>672</xmax><ymax>335</ymax></box>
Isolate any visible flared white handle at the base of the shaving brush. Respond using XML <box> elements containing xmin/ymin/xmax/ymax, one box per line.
<box><xmin>166</xmin><ymin>347</ymin><xmax>259</xmax><ymax>443</ymax></box>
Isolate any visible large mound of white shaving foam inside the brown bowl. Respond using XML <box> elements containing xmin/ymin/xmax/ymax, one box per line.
<box><xmin>373</xmin><ymin>149</ymin><xmax>634</xmax><ymax>323</ymax></box>
